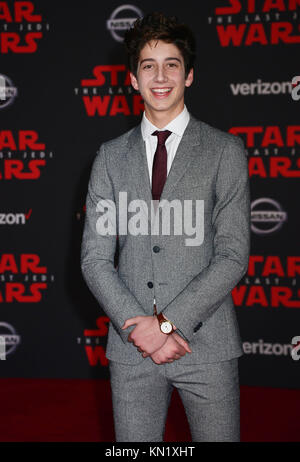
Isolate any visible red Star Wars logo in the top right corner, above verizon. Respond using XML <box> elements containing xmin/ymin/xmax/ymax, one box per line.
<box><xmin>208</xmin><ymin>0</ymin><xmax>300</xmax><ymax>47</ymax></box>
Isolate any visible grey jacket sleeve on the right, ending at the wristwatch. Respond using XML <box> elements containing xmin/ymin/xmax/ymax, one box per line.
<box><xmin>162</xmin><ymin>138</ymin><xmax>250</xmax><ymax>341</ymax></box>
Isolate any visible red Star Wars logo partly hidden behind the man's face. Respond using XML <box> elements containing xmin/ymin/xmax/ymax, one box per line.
<box><xmin>74</xmin><ymin>64</ymin><xmax>144</xmax><ymax>117</ymax></box>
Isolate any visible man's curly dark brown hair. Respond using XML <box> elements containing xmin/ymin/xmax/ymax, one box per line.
<box><xmin>124</xmin><ymin>12</ymin><xmax>196</xmax><ymax>77</ymax></box>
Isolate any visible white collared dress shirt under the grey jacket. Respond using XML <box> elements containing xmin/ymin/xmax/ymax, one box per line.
<box><xmin>141</xmin><ymin>106</ymin><xmax>190</xmax><ymax>303</ymax></box>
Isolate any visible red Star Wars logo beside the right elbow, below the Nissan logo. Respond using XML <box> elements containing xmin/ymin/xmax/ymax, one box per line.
<box><xmin>232</xmin><ymin>255</ymin><xmax>300</xmax><ymax>308</ymax></box>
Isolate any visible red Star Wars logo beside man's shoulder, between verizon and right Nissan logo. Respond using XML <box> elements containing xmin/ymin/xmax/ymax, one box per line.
<box><xmin>229</xmin><ymin>125</ymin><xmax>300</xmax><ymax>178</ymax></box>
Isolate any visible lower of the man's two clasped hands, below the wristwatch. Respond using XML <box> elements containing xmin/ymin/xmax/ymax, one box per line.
<box><xmin>143</xmin><ymin>332</ymin><xmax>192</xmax><ymax>364</ymax></box>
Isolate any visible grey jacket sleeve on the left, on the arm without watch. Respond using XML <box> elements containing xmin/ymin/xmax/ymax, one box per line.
<box><xmin>81</xmin><ymin>145</ymin><xmax>145</xmax><ymax>343</ymax></box>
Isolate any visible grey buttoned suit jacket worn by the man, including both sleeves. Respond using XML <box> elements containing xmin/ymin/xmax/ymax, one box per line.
<box><xmin>81</xmin><ymin>116</ymin><xmax>250</xmax><ymax>364</ymax></box>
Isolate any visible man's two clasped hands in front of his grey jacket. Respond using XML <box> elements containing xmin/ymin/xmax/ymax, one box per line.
<box><xmin>122</xmin><ymin>316</ymin><xmax>192</xmax><ymax>364</ymax></box>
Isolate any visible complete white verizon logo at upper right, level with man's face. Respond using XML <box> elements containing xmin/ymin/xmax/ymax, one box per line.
<box><xmin>230</xmin><ymin>79</ymin><xmax>293</xmax><ymax>96</ymax></box>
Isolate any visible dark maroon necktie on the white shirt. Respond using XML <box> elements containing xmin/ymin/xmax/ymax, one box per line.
<box><xmin>152</xmin><ymin>130</ymin><xmax>172</xmax><ymax>200</ymax></box>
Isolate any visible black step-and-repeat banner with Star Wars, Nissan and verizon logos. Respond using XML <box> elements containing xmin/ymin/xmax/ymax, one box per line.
<box><xmin>0</xmin><ymin>0</ymin><xmax>300</xmax><ymax>388</ymax></box>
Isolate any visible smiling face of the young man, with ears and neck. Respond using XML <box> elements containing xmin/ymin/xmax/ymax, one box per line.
<box><xmin>130</xmin><ymin>40</ymin><xmax>193</xmax><ymax>128</ymax></box>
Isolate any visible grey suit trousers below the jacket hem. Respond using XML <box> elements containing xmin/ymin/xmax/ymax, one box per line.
<box><xmin>109</xmin><ymin>358</ymin><xmax>240</xmax><ymax>442</ymax></box>
